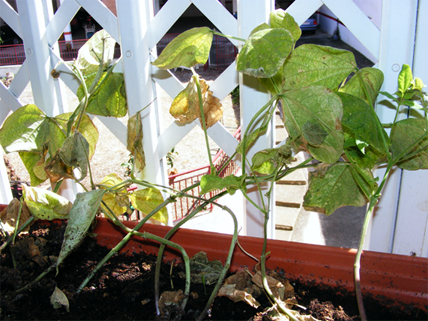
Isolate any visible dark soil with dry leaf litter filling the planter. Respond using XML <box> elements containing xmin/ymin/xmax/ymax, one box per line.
<box><xmin>0</xmin><ymin>223</ymin><xmax>427</xmax><ymax>320</ymax></box>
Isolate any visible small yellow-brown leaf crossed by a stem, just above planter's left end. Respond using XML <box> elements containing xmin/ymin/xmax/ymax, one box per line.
<box><xmin>100</xmin><ymin>174</ymin><xmax>130</xmax><ymax>215</ymax></box>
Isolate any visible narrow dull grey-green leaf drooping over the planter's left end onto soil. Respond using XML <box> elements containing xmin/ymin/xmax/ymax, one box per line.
<box><xmin>56</xmin><ymin>189</ymin><xmax>106</xmax><ymax>274</ymax></box>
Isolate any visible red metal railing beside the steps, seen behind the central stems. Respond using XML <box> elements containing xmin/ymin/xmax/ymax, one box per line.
<box><xmin>169</xmin><ymin>128</ymin><xmax>241</xmax><ymax>222</ymax></box>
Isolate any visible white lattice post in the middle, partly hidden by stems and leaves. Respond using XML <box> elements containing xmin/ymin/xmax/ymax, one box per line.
<box><xmin>238</xmin><ymin>0</ymin><xmax>275</xmax><ymax>238</ymax></box>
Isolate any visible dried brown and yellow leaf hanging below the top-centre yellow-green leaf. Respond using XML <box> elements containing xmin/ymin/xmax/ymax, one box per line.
<box><xmin>169</xmin><ymin>76</ymin><xmax>223</xmax><ymax>128</ymax></box>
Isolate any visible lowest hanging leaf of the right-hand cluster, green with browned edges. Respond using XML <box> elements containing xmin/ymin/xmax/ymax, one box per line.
<box><xmin>303</xmin><ymin>163</ymin><xmax>367</xmax><ymax>215</ymax></box>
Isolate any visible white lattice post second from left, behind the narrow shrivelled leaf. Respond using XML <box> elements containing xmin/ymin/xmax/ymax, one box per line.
<box><xmin>116</xmin><ymin>0</ymin><xmax>166</xmax><ymax>208</ymax></box>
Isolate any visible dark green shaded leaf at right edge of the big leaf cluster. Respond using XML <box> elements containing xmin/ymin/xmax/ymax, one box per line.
<box><xmin>338</xmin><ymin>93</ymin><xmax>388</xmax><ymax>154</ymax></box>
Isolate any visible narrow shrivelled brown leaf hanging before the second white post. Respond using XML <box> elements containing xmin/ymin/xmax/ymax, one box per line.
<box><xmin>126</xmin><ymin>112</ymin><xmax>146</xmax><ymax>173</ymax></box>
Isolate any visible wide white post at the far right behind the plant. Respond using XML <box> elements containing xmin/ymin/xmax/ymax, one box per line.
<box><xmin>369</xmin><ymin>0</ymin><xmax>428</xmax><ymax>256</ymax></box>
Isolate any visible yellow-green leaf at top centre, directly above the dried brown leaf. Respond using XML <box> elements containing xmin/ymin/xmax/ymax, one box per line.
<box><xmin>153</xmin><ymin>27</ymin><xmax>213</xmax><ymax>69</ymax></box>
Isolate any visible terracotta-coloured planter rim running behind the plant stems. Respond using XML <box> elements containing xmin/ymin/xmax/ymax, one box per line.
<box><xmin>94</xmin><ymin>219</ymin><xmax>428</xmax><ymax>312</ymax></box>
